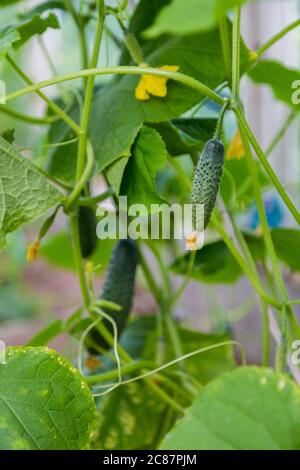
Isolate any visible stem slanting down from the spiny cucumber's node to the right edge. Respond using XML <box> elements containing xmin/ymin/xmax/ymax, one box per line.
<box><xmin>234</xmin><ymin>108</ymin><xmax>300</xmax><ymax>225</ymax></box>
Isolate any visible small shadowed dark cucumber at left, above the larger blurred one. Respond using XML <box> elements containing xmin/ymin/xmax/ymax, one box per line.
<box><xmin>78</xmin><ymin>206</ymin><xmax>98</xmax><ymax>258</ymax></box>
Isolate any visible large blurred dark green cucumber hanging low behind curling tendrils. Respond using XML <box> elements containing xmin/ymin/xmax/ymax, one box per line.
<box><xmin>87</xmin><ymin>240</ymin><xmax>138</xmax><ymax>353</ymax></box>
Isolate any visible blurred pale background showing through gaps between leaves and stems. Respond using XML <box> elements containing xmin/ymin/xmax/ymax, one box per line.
<box><xmin>0</xmin><ymin>0</ymin><xmax>300</xmax><ymax>363</ymax></box>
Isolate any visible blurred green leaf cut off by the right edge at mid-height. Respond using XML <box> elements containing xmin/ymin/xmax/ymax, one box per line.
<box><xmin>271</xmin><ymin>228</ymin><xmax>300</xmax><ymax>272</ymax></box>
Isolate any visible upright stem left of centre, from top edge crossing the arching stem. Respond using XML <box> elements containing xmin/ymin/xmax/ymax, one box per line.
<box><xmin>76</xmin><ymin>0</ymin><xmax>105</xmax><ymax>181</ymax></box>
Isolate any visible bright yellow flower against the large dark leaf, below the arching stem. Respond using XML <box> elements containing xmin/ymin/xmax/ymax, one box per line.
<box><xmin>135</xmin><ymin>65</ymin><xmax>179</xmax><ymax>101</ymax></box>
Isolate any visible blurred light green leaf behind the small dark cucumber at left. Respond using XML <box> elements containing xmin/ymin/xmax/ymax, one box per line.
<box><xmin>40</xmin><ymin>231</ymin><xmax>115</xmax><ymax>273</ymax></box>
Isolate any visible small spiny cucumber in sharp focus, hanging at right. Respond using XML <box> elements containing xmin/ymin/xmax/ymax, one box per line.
<box><xmin>192</xmin><ymin>139</ymin><xmax>224</xmax><ymax>230</ymax></box>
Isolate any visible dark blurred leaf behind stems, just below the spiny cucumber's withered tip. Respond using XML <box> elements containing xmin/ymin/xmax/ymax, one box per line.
<box><xmin>171</xmin><ymin>233</ymin><xmax>264</xmax><ymax>284</ymax></box>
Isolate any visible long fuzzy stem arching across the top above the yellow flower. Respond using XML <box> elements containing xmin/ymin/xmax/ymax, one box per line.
<box><xmin>5</xmin><ymin>66</ymin><xmax>225</xmax><ymax>106</ymax></box>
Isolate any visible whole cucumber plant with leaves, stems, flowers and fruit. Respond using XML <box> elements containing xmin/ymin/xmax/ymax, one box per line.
<box><xmin>0</xmin><ymin>0</ymin><xmax>300</xmax><ymax>451</ymax></box>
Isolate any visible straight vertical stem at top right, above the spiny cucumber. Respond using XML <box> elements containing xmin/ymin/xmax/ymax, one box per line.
<box><xmin>232</xmin><ymin>7</ymin><xmax>241</xmax><ymax>103</ymax></box>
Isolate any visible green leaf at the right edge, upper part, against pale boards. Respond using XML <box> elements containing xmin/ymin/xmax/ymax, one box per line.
<box><xmin>249</xmin><ymin>60</ymin><xmax>300</xmax><ymax>108</ymax></box>
